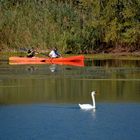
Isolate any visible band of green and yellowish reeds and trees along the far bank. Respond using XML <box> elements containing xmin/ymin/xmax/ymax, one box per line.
<box><xmin>0</xmin><ymin>0</ymin><xmax>140</xmax><ymax>53</ymax></box>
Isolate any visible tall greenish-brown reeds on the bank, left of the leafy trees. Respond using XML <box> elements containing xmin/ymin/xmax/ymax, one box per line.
<box><xmin>0</xmin><ymin>0</ymin><xmax>80</xmax><ymax>51</ymax></box>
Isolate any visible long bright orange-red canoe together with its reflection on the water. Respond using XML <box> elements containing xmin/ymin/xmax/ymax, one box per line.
<box><xmin>9</xmin><ymin>55</ymin><xmax>84</xmax><ymax>66</ymax></box>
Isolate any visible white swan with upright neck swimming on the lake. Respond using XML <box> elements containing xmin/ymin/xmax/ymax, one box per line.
<box><xmin>79</xmin><ymin>91</ymin><xmax>96</xmax><ymax>110</ymax></box>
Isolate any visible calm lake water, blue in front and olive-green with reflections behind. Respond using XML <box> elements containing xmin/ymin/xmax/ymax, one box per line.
<box><xmin>0</xmin><ymin>59</ymin><xmax>140</xmax><ymax>140</ymax></box>
